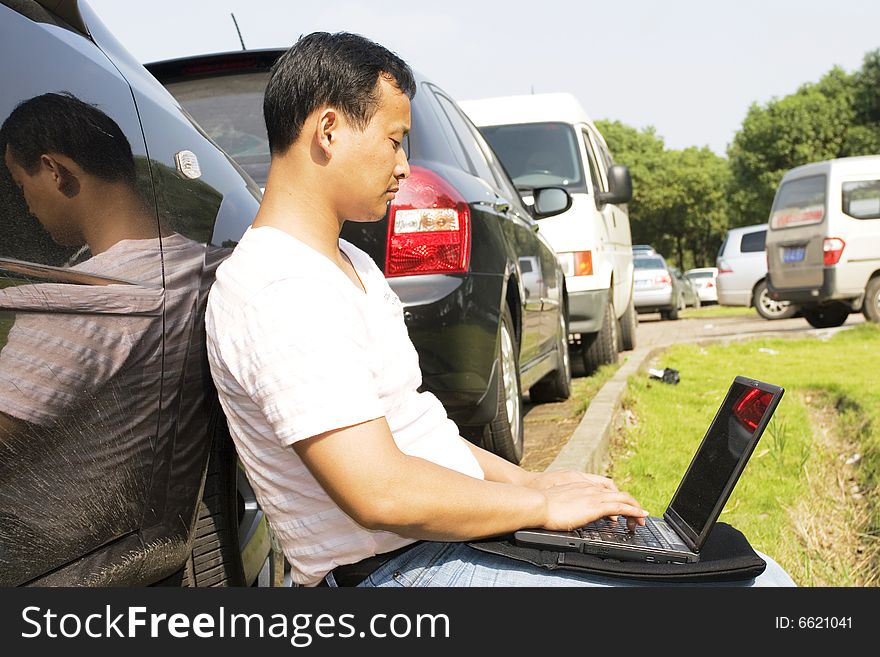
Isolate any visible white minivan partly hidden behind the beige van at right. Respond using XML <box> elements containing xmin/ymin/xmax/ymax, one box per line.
<box><xmin>717</xmin><ymin>224</ymin><xmax>798</xmax><ymax>319</ymax></box>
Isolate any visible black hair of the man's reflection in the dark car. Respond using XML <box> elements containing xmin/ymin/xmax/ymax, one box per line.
<box><xmin>0</xmin><ymin>92</ymin><xmax>136</xmax><ymax>185</ymax></box>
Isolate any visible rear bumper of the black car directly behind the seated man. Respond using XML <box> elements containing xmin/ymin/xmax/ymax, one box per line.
<box><xmin>388</xmin><ymin>274</ymin><xmax>504</xmax><ymax>426</ymax></box>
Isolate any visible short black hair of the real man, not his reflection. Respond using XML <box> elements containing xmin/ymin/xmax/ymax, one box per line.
<box><xmin>263</xmin><ymin>32</ymin><xmax>416</xmax><ymax>154</ymax></box>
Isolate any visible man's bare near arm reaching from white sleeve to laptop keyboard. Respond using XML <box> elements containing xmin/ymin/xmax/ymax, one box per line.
<box><xmin>293</xmin><ymin>418</ymin><xmax>647</xmax><ymax>540</ymax></box>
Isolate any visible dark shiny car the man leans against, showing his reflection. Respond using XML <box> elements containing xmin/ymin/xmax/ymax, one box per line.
<box><xmin>0</xmin><ymin>0</ymin><xmax>280</xmax><ymax>586</ymax></box>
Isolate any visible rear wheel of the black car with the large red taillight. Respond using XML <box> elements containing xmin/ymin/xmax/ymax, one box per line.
<box><xmin>483</xmin><ymin>307</ymin><xmax>523</xmax><ymax>463</ymax></box>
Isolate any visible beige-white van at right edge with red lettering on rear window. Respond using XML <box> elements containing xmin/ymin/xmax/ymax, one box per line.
<box><xmin>767</xmin><ymin>155</ymin><xmax>880</xmax><ymax>328</ymax></box>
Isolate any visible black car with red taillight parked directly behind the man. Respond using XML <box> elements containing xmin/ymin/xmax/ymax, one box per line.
<box><xmin>146</xmin><ymin>49</ymin><xmax>571</xmax><ymax>462</ymax></box>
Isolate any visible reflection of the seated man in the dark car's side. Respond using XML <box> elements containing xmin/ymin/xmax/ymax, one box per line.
<box><xmin>0</xmin><ymin>93</ymin><xmax>205</xmax><ymax>584</ymax></box>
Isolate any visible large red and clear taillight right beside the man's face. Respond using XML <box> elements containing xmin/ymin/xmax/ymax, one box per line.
<box><xmin>385</xmin><ymin>166</ymin><xmax>471</xmax><ymax>276</ymax></box>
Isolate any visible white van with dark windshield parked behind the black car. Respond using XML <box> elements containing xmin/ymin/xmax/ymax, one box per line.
<box><xmin>459</xmin><ymin>93</ymin><xmax>638</xmax><ymax>373</ymax></box>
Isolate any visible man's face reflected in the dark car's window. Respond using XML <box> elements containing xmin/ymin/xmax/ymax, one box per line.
<box><xmin>3</xmin><ymin>146</ymin><xmax>82</xmax><ymax>246</ymax></box>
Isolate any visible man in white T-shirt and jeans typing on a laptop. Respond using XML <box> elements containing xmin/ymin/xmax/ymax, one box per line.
<box><xmin>206</xmin><ymin>33</ymin><xmax>790</xmax><ymax>586</ymax></box>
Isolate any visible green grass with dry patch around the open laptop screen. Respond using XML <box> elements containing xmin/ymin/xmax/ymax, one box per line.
<box><xmin>609</xmin><ymin>322</ymin><xmax>880</xmax><ymax>586</ymax></box>
